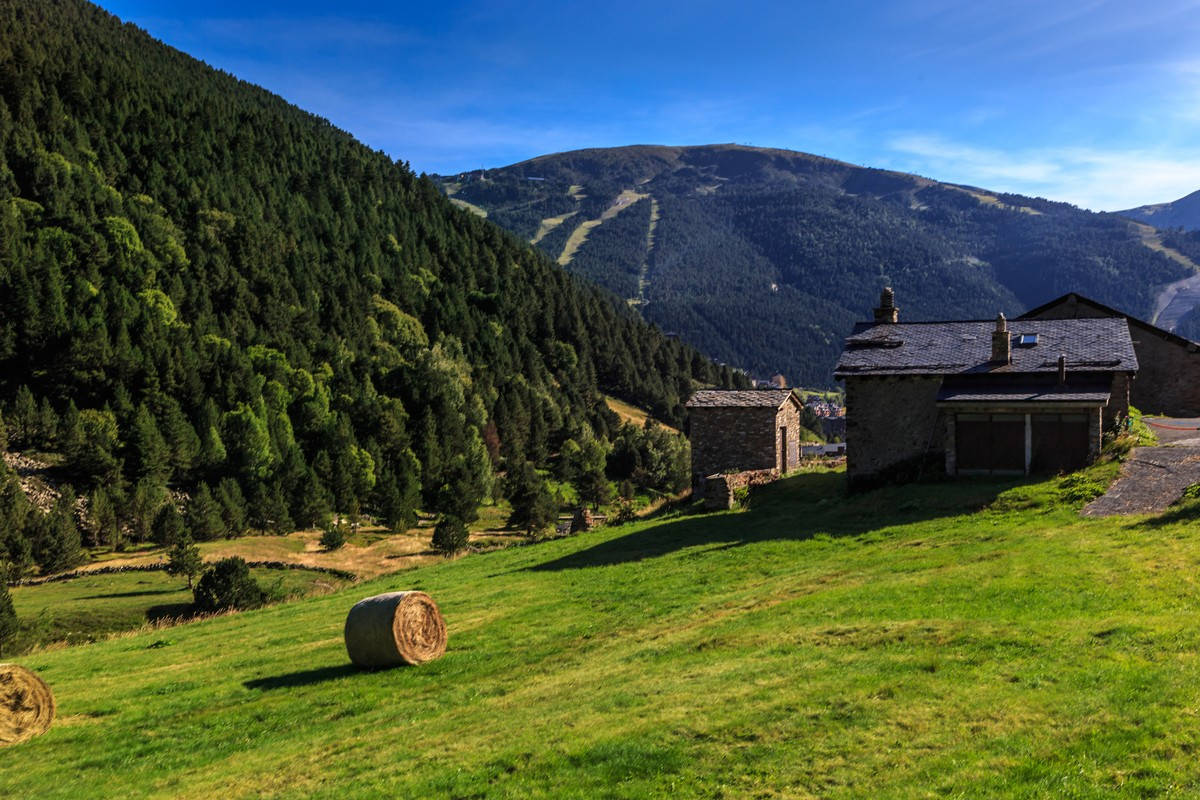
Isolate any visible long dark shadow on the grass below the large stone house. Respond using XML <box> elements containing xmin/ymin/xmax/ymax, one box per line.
<box><xmin>527</xmin><ymin>471</ymin><xmax>1022</xmax><ymax>571</ymax></box>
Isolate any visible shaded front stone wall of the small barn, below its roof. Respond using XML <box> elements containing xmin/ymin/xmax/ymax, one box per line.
<box><xmin>688</xmin><ymin>403</ymin><xmax>782</xmax><ymax>481</ymax></box>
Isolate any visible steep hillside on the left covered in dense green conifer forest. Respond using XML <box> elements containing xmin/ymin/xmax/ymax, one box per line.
<box><xmin>0</xmin><ymin>0</ymin><xmax>744</xmax><ymax>570</ymax></box>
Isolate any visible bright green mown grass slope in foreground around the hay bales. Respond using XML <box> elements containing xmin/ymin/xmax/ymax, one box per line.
<box><xmin>7</xmin><ymin>464</ymin><xmax>1200</xmax><ymax>798</ymax></box>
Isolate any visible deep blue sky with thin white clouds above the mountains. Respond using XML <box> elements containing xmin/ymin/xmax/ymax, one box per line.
<box><xmin>101</xmin><ymin>0</ymin><xmax>1200</xmax><ymax>210</ymax></box>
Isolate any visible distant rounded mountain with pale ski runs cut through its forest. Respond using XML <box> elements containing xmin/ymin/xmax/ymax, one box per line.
<box><xmin>437</xmin><ymin>145</ymin><xmax>1189</xmax><ymax>385</ymax></box>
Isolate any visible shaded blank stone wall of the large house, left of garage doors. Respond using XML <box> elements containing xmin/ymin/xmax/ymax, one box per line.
<box><xmin>846</xmin><ymin>375</ymin><xmax>946</xmax><ymax>486</ymax></box>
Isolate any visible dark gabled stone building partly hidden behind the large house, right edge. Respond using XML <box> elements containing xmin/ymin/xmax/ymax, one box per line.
<box><xmin>1018</xmin><ymin>291</ymin><xmax>1200</xmax><ymax>416</ymax></box>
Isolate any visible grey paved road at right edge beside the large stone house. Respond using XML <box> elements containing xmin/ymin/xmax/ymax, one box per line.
<box><xmin>1081</xmin><ymin>417</ymin><xmax>1200</xmax><ymax>517</ymax></box>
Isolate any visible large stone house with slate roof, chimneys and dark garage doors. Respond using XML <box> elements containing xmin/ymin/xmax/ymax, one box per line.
<box><xmin>834</xmin><ymin>289</ymin><xmax>1138</xmax><ymax>488</ymax></box>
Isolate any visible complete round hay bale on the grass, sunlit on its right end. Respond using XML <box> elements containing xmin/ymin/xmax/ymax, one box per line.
<box><xmin>346</xmin><ymin>591</ymin><xmax>446</xmax><ymax>669</ymax></box>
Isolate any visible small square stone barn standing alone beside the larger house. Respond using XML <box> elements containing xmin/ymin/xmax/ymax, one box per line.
<box><xmin>686</xmin><ymin>389</ymin><xmax>803</xmax><ymax>485</ymax></box>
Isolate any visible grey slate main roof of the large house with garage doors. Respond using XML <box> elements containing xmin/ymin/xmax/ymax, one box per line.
<box><xmin>834</xmin><ymin>318</ymin><xmax>1138</xmax><ymax>378</ymax></box>
